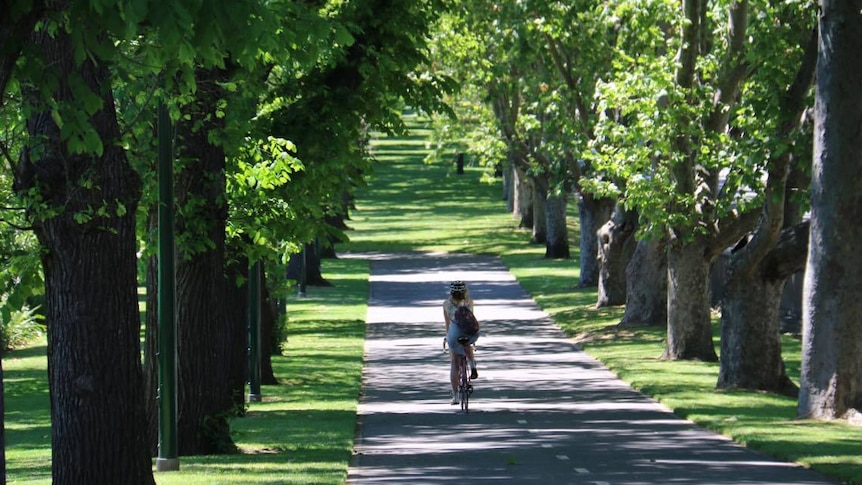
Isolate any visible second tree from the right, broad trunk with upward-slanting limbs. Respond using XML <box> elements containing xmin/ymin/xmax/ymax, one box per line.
<box><xmin>718</xmin><ymin>18</ymin><xmax>817</xmax><ymax>396</ymax></box>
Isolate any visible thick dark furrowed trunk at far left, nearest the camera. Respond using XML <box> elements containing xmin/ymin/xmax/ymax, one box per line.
<box><xmin>15</xmin><ymin>28</ymin><xmax>154</xmax><ymax>485</ymax></box>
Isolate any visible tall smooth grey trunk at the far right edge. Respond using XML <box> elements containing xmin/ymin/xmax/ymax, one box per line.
<box><xmin>798</xmin><ymin>0</ymin><xmax>862</xmax><ymax>419</ymax></box>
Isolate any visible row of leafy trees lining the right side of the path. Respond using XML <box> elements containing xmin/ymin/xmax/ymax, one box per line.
<box><xmin>432</xmin><ymin>0</ymin><xmax>862</xmax><ymax>430</ymax></box>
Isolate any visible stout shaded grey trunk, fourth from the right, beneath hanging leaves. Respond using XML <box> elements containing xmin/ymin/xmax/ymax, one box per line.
<box><xmin>619</xmin><ymin>238</ymin><xmax>667</xmax><ymax>326</ymax></box>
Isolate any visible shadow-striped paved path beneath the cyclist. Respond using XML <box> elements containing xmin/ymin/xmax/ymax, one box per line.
<box><xmin>347</xmin><ymin>254</ymin><xmax>835</xmax><ymax>485</ymax></box>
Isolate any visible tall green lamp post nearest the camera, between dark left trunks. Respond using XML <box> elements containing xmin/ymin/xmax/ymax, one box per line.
<box><xmin>156</xmin><ymin>102</ymin><xmax>180</xmax><ymax>471</ymax></box>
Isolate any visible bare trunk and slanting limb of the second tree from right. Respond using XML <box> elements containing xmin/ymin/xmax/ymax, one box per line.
<box><xmin>717</xmin><ymin>25</ymin><xmax>817</xmax><ymax>396</ymax></box>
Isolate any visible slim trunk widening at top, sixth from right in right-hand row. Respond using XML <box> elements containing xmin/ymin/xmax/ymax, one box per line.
<box><xmin>578</xmin><ymin>193</ymin><xmax>617</xmax><ymax>288</ymax></box>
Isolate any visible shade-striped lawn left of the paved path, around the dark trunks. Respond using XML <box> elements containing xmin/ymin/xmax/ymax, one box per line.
<box><xmin>3</xmin><ymin>255</ymin><xmax>368</xmax><ymax>485</ymax></box>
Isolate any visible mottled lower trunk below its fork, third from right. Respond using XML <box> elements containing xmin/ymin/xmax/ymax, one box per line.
<box><xmin>663</xmin><ymin>239</ymin><xmax>718</xmax><ymax>362</ymax></box>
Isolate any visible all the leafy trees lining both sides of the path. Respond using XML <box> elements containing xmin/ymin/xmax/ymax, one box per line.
<box><xmin>0</xmin><ymin>0</ymin><xmax>862</xmax><ymax>484</ymax></box>
